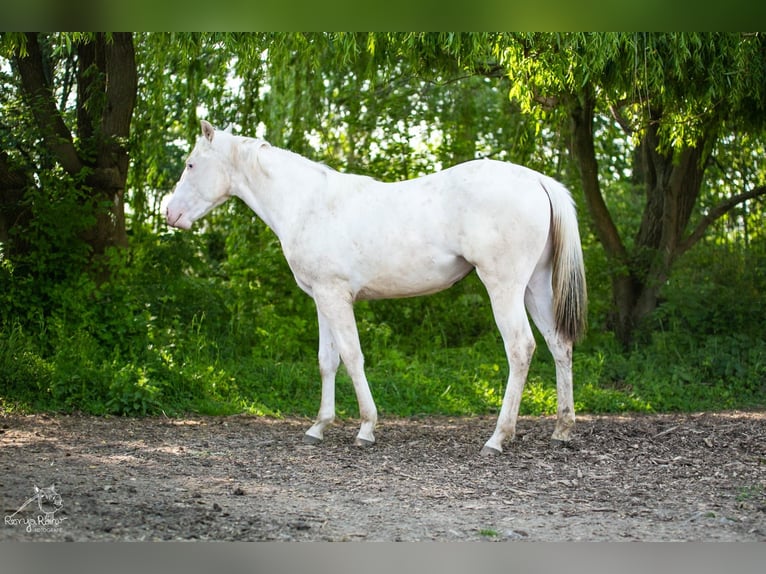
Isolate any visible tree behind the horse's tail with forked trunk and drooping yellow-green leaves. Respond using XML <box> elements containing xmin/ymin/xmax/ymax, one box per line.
<box><xmin>507</xmin><ymin>34</ymin><xmax>766</xmax><ymax>345</ymax></box>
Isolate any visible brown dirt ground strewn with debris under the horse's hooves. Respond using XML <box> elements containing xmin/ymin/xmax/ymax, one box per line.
<box><xmin>0</xmin><ymin>412</ymin><xmax>766</xmax><ymax>541</ymax></box>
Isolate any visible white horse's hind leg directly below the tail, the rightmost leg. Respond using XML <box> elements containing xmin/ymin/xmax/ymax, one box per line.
<box><xmin>524</xmin><ymin>269</ymin><xmax>575</xmax><ymax>444</ymax></box>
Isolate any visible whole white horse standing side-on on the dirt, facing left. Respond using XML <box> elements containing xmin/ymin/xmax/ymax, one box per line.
<box><xmin>166</xmin><ymin>121</ymin><xmax>587</xmax><ymax>454</ymax></box>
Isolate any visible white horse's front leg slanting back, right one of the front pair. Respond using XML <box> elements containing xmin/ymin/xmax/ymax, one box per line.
<box><xmin>312</xmin><ymin>290</ymin><xmax>378</xmax><ymax>446</ymax></box>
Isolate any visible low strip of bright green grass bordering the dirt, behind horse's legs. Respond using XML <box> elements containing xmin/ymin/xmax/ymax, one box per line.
<box><xmin>0</xmin><ymin>318</ymin><xmax>764</xmax><ymax>418</ymax></box>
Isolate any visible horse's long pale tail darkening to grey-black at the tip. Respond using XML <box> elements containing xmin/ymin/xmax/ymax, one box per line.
<box><xmin>541</xmin><ymin>179</ymin><xmax>588</xmax><ymax>342</ymax></box>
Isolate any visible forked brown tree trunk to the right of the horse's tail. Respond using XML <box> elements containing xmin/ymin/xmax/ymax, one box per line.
<box><xmin>570</xmin><ymin>87</ymin><xmax>713</xmax><ymax>347</ymax></box>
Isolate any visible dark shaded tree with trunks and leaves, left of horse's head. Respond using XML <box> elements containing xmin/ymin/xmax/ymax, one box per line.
<box><xmin>0</xmin><ymin>33</ymin><xmax>137</xmax><ymax>270</ymax></box>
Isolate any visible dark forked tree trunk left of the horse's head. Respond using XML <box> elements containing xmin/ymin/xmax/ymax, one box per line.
<box><xmin>14</xmin><ymin>33</ymin><xmax>137</xmax><ymax>270</ymax></box>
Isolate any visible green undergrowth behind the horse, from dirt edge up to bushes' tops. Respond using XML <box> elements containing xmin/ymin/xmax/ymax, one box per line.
<box><xmin>0</xmin><ymin>232</ymin><xmax>766</xmax><ymax>417</ymax></box>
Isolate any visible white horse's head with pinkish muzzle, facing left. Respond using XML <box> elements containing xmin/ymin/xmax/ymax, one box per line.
<box><xmin>165</xmin><ymin>120</ymin><xmax>237</xmax><ymax>229</ymax></box>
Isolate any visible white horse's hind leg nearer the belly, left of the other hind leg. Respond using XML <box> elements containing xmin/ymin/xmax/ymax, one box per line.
<box><xmin>479</xmin><ymin>271</ymin><xmax>535</xmax><ymax>454</ymax></box>
